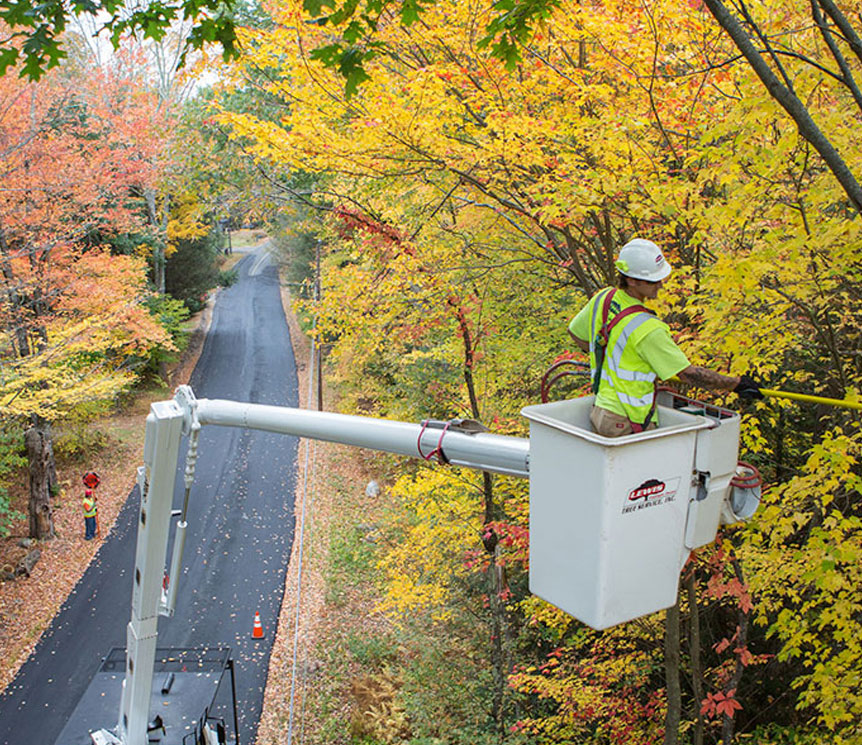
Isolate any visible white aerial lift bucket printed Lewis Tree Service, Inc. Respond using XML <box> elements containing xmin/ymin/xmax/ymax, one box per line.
<box><xmin>521</xmin><ymin>394</ymin><xmax>739</xmax><ymax>629</ymax></box>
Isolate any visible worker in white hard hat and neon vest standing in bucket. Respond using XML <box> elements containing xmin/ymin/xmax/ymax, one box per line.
<box><xmin>569</xmin><ymin>238</ymin><xmax>763</xmax><ymax>437</ymax></box>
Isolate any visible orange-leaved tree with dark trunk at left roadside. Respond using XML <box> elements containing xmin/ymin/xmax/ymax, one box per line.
<box><xmin>0</xmin><ymin>62</ymin><xmax>176</xmax><ymax>538</ymax></box>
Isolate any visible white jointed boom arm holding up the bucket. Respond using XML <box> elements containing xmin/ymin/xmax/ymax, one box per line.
<box><xmin>117</xmin><ymin>386</ymin><xmax>530</xmax><ymax>745</ymax></box>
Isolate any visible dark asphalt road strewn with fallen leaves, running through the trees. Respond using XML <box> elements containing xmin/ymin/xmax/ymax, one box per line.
<box><xmin>0</xmin><ymin>247</ymin><xmax>298</xmax><ymax>745</ymax></box>
